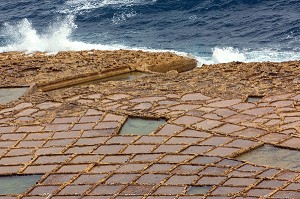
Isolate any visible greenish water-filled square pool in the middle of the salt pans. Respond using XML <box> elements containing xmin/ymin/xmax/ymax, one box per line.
<box><xmin>120</xmin><ymin>117</ymin><xmax>166</xmax><ymax>135</ymax></box>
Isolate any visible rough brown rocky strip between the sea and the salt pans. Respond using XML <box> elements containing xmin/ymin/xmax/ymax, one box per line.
<box><xmin>0</xmin><ymin>50</ymin><xmax>300</xmax><ymax>109</ymax></box>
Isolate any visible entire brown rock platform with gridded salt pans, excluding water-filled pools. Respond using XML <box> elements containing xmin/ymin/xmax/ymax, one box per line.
<box><xmin>0</xmin><ymin>51</ymin><xmax>300</xmax><ymax>199</ymax></box>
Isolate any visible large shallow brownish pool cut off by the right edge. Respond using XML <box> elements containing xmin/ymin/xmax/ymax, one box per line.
<box><xmin>237</xmin><ymin>145</ymin><xmax>300</xmax><ymax>171</ymax></box>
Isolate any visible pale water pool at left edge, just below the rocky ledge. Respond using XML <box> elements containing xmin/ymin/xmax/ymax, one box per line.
<box><xmin>0</xmin><ymin>87</ymin><xmax>29</xmax><ymax>104</ymax></box>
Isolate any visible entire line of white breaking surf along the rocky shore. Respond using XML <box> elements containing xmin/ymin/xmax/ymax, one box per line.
<box><xmin>0</xmin><ymin>15</ymin><xmax>300</xmax><ymax>66</ymax></box>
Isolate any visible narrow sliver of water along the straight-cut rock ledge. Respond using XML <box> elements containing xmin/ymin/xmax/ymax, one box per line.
<box><xmin>82</xmin><ymin>71</ymin><xmax>149</xmax><ymax>85</ymax></box>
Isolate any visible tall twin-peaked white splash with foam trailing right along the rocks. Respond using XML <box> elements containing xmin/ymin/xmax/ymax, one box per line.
<box><xmin>0</xmin><ymin>15</ymin><xmax>125</xmax><ymax>53</ymax></box>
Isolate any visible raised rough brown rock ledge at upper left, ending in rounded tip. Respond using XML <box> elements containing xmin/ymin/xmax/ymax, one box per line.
<box><xmin>0</xmin><ymin>50</ymin><xmax>197</xmax><ymax>86</ymax></box>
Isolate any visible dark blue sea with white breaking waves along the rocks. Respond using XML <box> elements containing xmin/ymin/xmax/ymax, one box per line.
<box><xmin>0</xmin><ymin>0</ymin><xmax>300</xmax><ymax>66</ymax></box>
